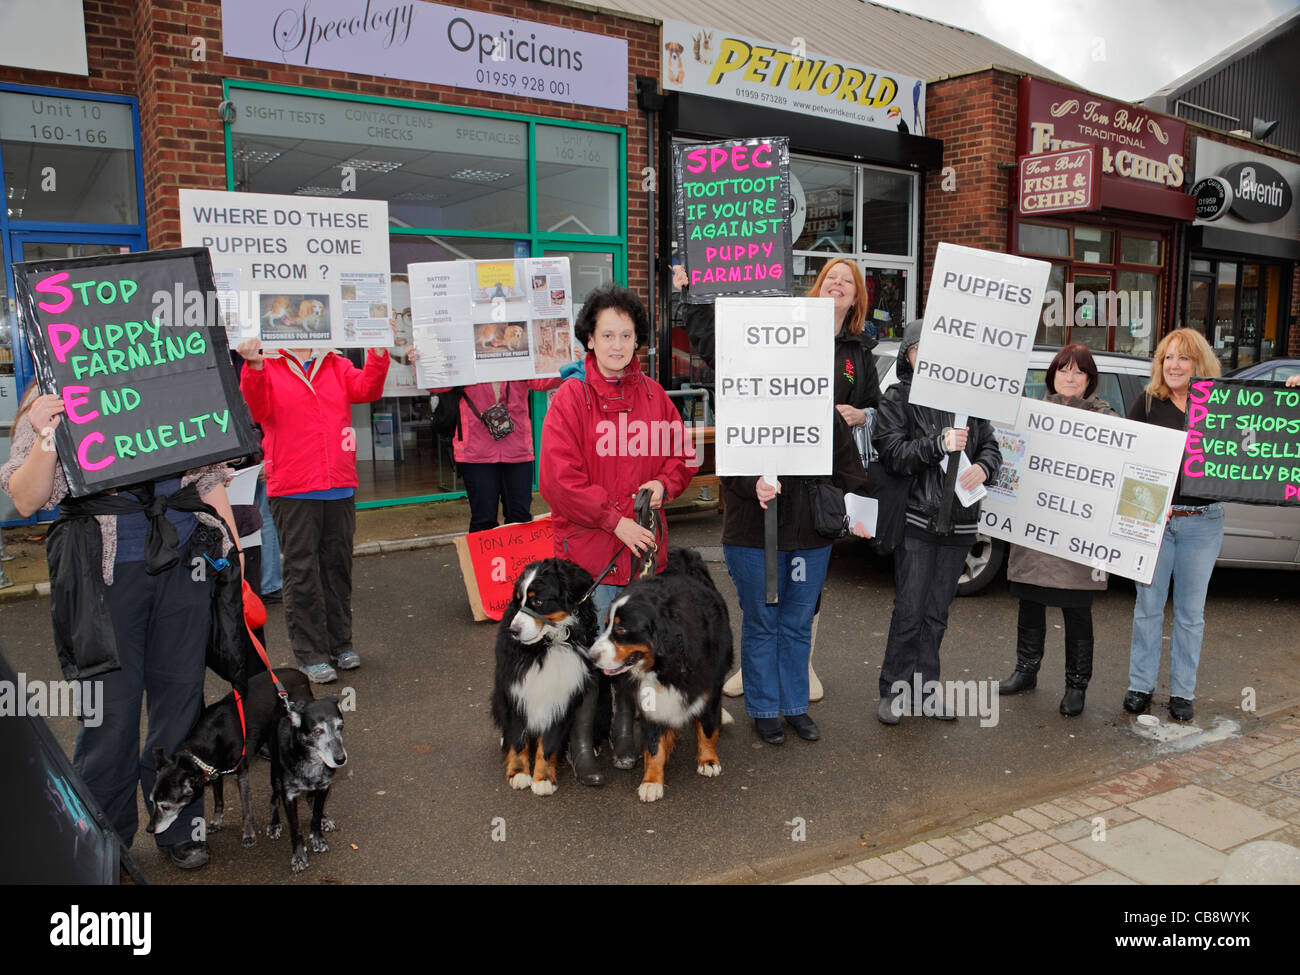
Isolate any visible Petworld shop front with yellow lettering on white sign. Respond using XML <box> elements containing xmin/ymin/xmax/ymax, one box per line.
<box><xmin>658</xmin><ymin>20</ymin><xmax>943</xmax><ymax>386</ymax></box>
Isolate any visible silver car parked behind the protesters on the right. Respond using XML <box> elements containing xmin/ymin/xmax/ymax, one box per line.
<box><xmin>875</xmin><ymin>351</ymin><xmax>1300</xmax><ymax>595</ymax></box>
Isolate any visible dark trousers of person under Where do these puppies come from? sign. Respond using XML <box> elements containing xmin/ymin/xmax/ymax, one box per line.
<box><xmin>270</xmin><ymin>498</ymin><xmax>356</xmax><ymax>667</ymax></box>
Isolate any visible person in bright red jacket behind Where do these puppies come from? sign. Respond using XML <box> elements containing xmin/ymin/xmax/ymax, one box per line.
<box><xmin>235</xmin><ymin>338</ymin><xmax>389</xmax><ymax>684</ymax></box>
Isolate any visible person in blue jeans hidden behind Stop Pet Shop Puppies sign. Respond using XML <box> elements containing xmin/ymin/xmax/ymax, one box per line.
<box><xmin>723</xmin><ymin>415</ymin><xmax>867</xmax><ymax>745</ymax></box>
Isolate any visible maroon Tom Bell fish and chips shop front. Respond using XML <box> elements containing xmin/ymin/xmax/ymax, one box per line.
<box><xmin>1008</xmin><ymin>78</ymin><xmax>1193</xmax><ymax>356</ymax></box>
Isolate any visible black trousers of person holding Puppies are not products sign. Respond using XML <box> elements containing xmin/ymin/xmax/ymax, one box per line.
<box><xmin>880</xmin><ymin>533</ymin><xmax>970</xmax><ymax>698</ymax></box>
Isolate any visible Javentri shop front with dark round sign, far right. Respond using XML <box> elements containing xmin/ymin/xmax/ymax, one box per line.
<box><xmin>1186</xmin><ymin>138</ymin><xmax>1300</xmax><ymax>371</ymax></box>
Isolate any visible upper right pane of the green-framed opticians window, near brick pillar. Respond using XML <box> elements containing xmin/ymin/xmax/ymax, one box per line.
<box><xmin>537</xmin><ymin>125</ymin><xmax>619</xmax><ymax>235</ymax></box>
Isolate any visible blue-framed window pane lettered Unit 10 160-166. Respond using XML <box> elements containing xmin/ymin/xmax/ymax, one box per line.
<box><xmin>0</xmin><ymin>91</ymin><xmax>140</xmax><ymax>225</ymax></box>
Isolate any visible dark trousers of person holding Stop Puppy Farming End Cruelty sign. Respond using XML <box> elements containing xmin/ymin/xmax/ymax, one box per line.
<box><xmin>73</xmin><ymin>559</ymin><xmax>212</xmax><ymax>846</ymax></box>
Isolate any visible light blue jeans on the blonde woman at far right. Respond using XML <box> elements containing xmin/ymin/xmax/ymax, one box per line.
<box><xmin>1128</xmin><ymin>503</ymin><xmax>1223</xmax><ymax>701</ymax></box>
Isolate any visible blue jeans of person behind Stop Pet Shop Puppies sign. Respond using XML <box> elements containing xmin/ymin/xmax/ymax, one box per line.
<box><xmin>723</xmin><ymin>545</ymin><xmax>831</xmax><ymax>718</ymax></box>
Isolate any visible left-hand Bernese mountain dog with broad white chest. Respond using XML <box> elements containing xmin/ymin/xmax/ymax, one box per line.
<box><xmin>491</xmin><ymin>559</ymin><xmax>598</xmax><ymax>796</ymax></box>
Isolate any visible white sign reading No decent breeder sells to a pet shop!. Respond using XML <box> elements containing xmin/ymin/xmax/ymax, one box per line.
<box><xmin>980</xmin><ymin>399</ymin><xmax>1186</xmax><ymax>582</ymax></box>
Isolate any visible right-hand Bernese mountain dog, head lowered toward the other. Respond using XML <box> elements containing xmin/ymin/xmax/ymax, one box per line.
<box><xmin>589</xmin><ymin>549</ymin><xmax>732</xmax><ymax>802</ymax></box>
